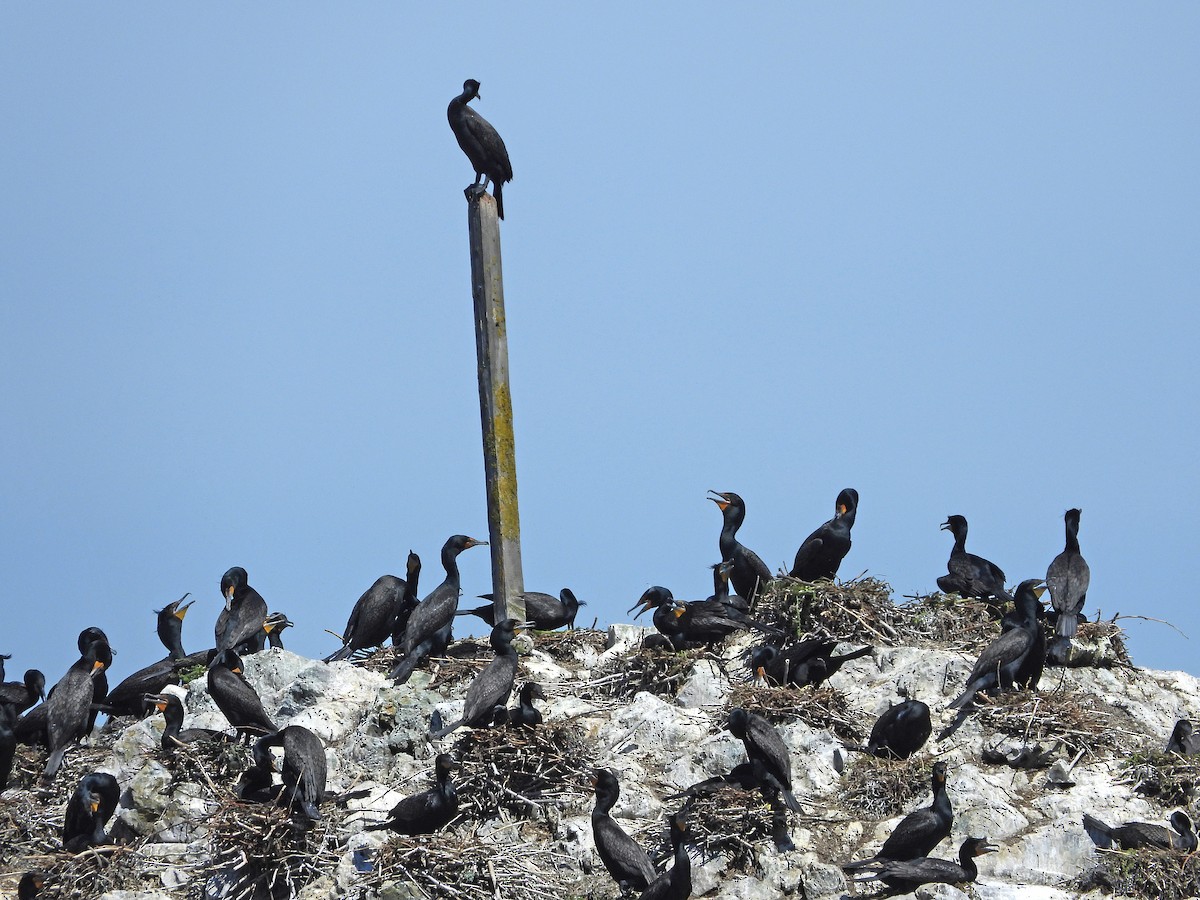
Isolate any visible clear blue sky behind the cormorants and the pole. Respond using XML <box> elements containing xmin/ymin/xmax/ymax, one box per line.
<box><xmin>0</xmin><ymin>2</ymin><xmax>1200</xmax><ymax>680</ymax></box>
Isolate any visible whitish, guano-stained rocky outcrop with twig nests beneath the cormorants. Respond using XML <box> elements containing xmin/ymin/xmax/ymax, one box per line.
<box><xmin>2</xmin><ymin>585</ymin><xmax>1200</xmax><ymax>900</ymax></box>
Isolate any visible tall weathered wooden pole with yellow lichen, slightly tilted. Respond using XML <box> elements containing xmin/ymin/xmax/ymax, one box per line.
<box><xmin>466</xmin><ymin>185</ymin><xmax>524</xmax><ymax>622</ymax></box>
